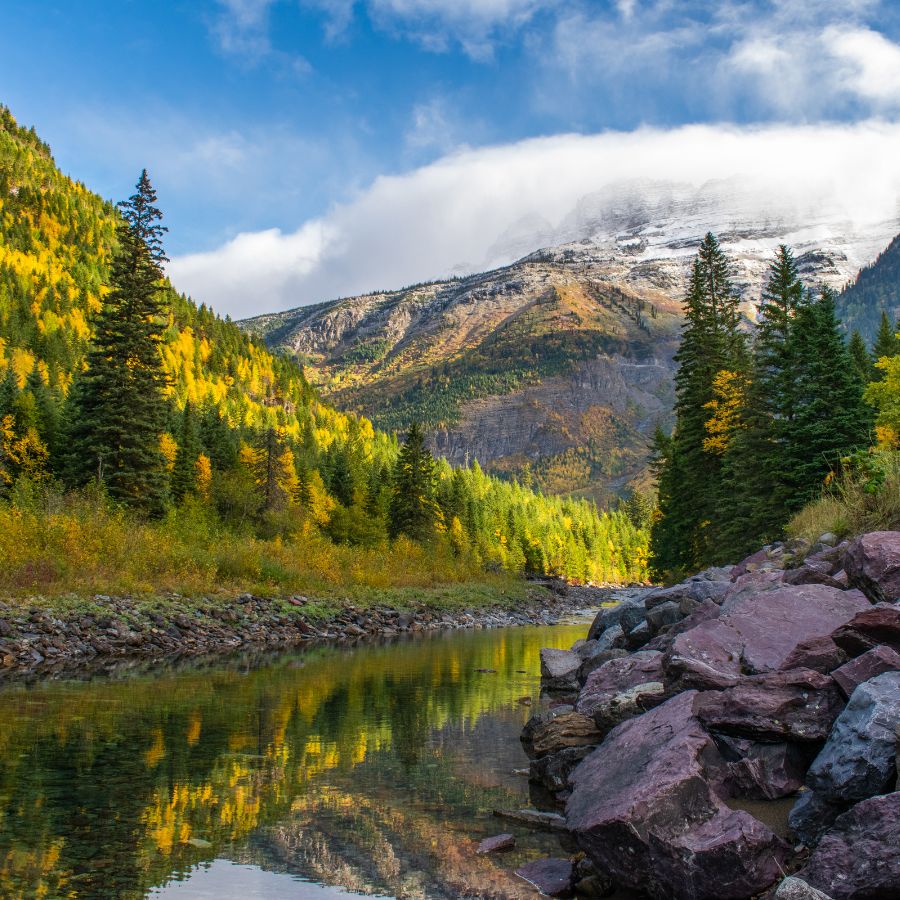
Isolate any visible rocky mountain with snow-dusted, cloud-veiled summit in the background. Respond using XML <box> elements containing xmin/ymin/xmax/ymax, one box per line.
<box><xmin>241</xmin><ymin>181</ymin><xmax>900</xmax><ymax>501</ymax></box>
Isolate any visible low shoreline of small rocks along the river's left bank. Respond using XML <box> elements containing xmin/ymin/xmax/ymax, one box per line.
<box><xmin>0</xmin><ymin>582</ymin><xmax>596</xmax><ymax>682</ymax></box>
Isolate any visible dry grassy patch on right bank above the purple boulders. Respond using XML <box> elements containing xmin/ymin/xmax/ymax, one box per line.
<box><xmin>787</xmin><ymin>451</ymin><xmax>900</xmax><ymax>541</ymax></box>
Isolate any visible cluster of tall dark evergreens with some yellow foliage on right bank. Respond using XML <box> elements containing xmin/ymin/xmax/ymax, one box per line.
<box><xmin>651</xmin><ymin>234</ymin><xmax>900</xmax><ymax>578</ymax></box>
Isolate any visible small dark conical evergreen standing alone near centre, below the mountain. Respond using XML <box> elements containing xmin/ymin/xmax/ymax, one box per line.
<box><xmin>388</xmin><ymin>422</ymin><xmax>437</xmax><ymax>541</ymax></box>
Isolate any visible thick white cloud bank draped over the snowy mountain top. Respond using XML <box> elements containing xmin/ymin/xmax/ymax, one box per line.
<box><xmin>170</xmin><ymin>121</ymin><xmax>900</xmax><ymax>317</ymax></box>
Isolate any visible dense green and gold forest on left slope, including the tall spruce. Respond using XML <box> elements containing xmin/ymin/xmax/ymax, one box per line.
<box><xmin>0</xmin><ymin>108</ymin><xmax>646</xmax><ymax>591</ymax></box>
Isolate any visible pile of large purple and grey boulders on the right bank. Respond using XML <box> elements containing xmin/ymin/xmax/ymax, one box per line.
<box><xmin>522</xmin><ymin>532</ymin><xmax>900</xmax><ymax>900</ymax></box>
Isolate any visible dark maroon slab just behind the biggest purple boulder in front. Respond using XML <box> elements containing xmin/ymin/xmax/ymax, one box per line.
<box><xmin>694</xmin><ymin>669</ymin><xmax>844</xmax><ymax>742</ymax></box>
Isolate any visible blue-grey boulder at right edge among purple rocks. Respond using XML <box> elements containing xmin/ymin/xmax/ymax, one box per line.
<box><xmin>790</xmin><ymin>672</ymin><xmax>900</xmax><ymax>844</ymax></box>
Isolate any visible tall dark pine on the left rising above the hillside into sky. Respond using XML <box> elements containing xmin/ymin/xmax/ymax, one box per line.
<box><xmin>66</xmin><ymin>170</ymin><xmax>167</xmax><ymax>515</ymax></box>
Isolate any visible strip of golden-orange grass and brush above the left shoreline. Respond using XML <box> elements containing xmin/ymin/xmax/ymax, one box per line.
<box><xmin>0</xmin><ymin>488</ymin><xmax>528</xmax><ymax>616</ymax></box>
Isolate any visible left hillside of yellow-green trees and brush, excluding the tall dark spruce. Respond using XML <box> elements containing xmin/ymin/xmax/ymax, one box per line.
<box><xmin>0</xmin><ymin>107</ymin><xmax>646</xmax><ymax>598</ymax></box>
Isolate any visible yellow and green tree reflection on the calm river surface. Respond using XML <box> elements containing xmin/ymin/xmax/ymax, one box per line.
<box><xmin>0</xmin><ymin>629</ymin><xmax>574</xmax><ymax>900</ymax></box>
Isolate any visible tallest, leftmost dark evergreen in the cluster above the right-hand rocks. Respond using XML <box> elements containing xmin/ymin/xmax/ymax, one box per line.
<box><xmin>651</xmin><ymin>234</ymin><xmax>746</xmax><ymax>574</ymax></box>
